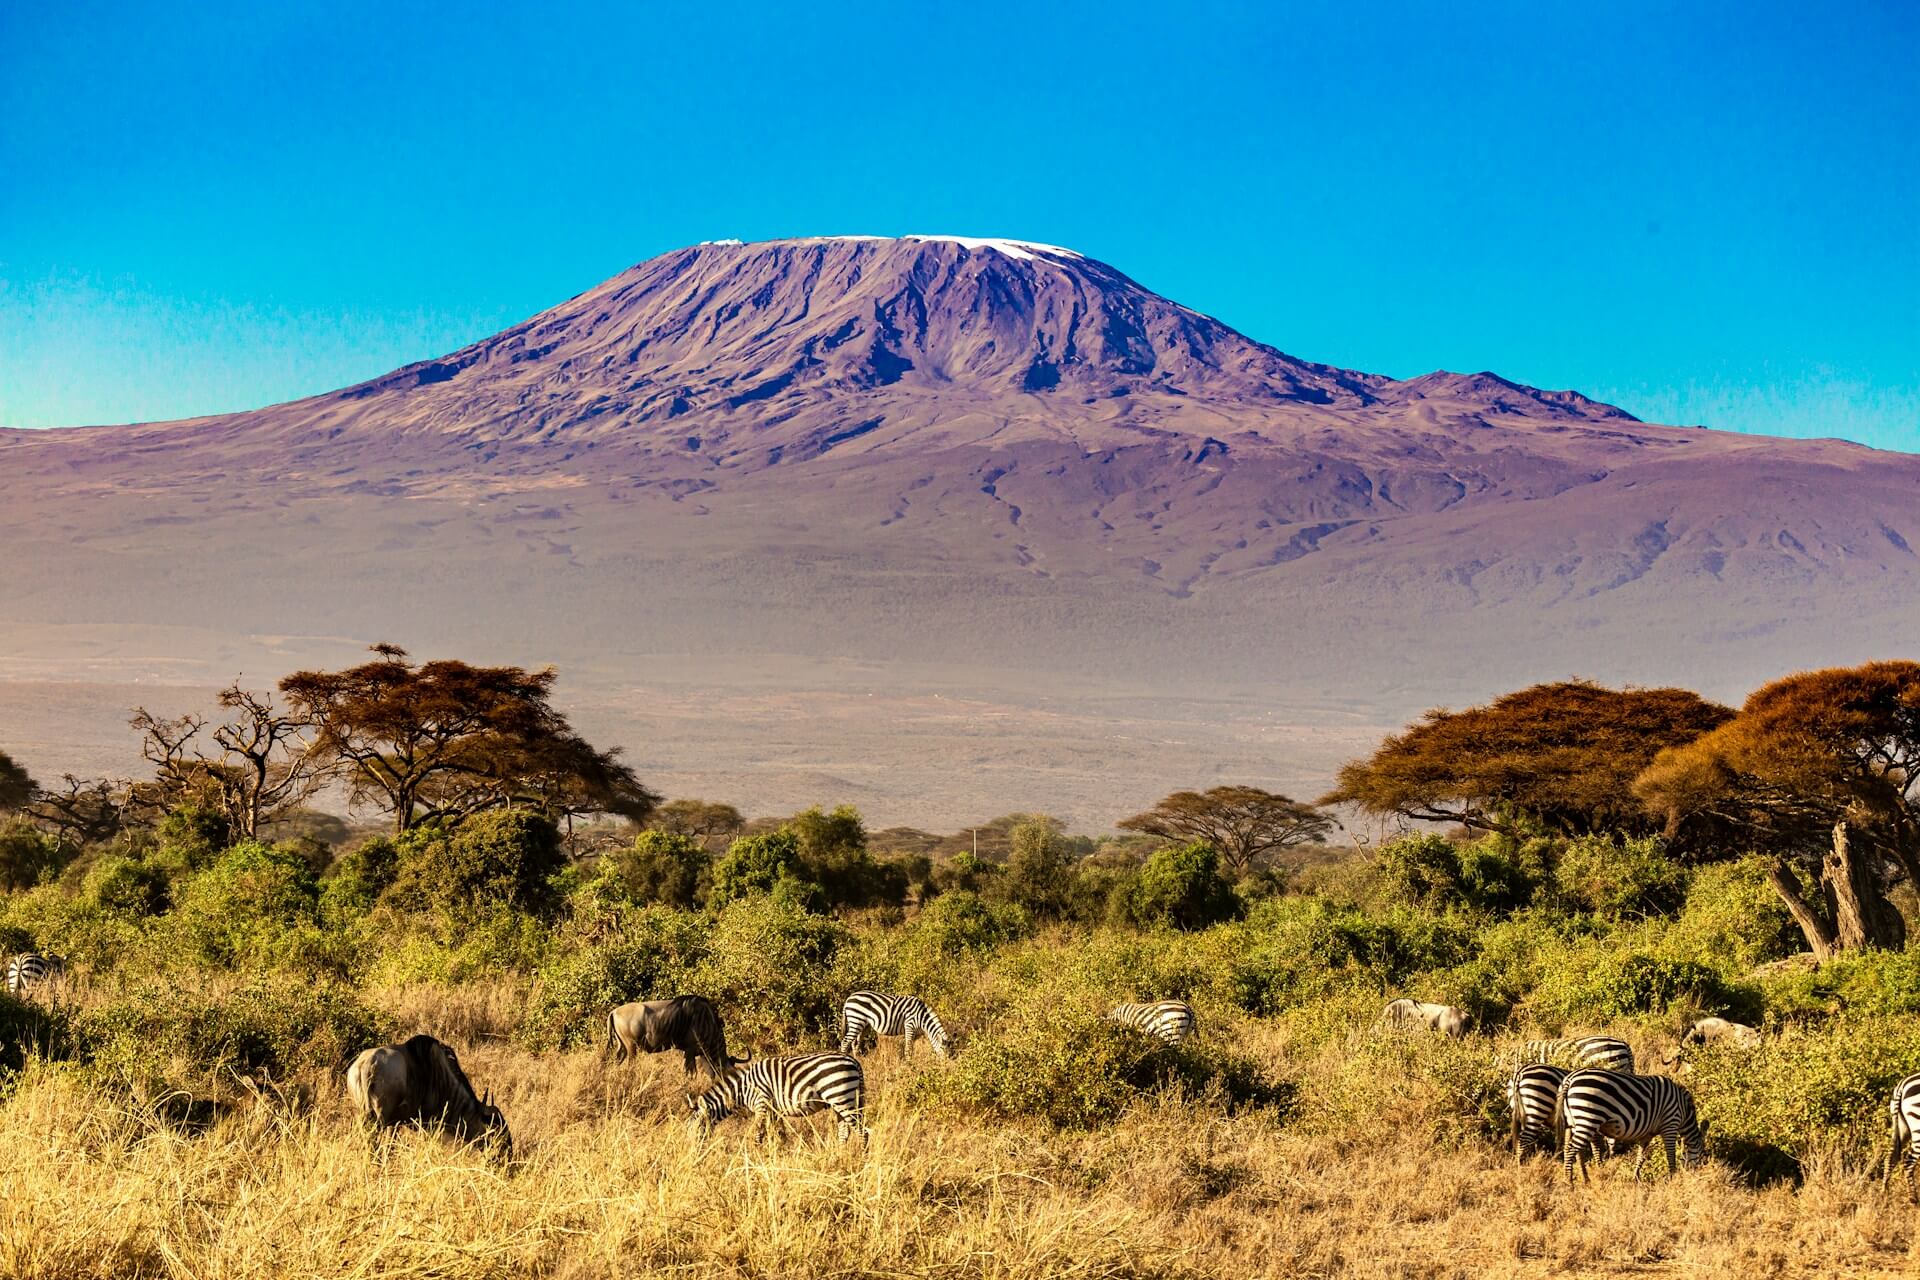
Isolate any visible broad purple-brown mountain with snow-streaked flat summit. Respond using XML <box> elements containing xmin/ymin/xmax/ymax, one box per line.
<box><xmin>0</xmin><ymin>236</ymin><xmax>1920</xmax><ymax>821</ymax></box>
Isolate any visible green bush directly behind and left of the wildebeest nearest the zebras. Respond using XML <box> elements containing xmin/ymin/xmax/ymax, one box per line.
<box><xmin>518</xmin><ymin>908</ymin><xmax>707</xmax><ymax>1050</ymax></box>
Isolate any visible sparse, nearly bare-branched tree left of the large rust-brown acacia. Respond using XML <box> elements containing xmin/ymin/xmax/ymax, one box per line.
<box><xmin>131</xmin><ymin>683</ymin><xmax>326</xmax><ymax>841</ymax></box>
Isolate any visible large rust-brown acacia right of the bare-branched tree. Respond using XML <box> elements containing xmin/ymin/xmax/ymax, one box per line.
<box><xmin>280</xmin><ymin>645</ymin><xmax>659</xmax><ymax>831</ymax></box>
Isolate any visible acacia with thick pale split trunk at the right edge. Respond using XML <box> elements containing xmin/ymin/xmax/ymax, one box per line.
<box><xmin>1634</xmin><ymin>662</ymin><xmax>1920</xmax><ymax>960</ymax></box>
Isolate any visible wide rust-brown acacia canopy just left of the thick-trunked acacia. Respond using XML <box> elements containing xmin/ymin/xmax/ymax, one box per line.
<box><xmin>1319</xmin><ymin>679</ymin><xmax>1734</xmax><ymax>835</ymax></box>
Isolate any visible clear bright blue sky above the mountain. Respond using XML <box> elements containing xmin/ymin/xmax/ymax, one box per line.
<box><xmin>0</xmin><ymin>0</ymin><xmax>1920</xmax><ymax>449</ymax></box>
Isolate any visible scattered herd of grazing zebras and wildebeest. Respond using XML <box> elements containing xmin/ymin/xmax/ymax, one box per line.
<box><xmin>6</xmin><ymin>952</ymin><xmax>1920</xmax><ymax>1201</ymax></box>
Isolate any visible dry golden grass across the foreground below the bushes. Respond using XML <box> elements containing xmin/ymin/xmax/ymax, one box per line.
<box><xmin>0</xmin><ymin>988</ymin><xmax>1920</xmax><ymax>1280</ymax></box>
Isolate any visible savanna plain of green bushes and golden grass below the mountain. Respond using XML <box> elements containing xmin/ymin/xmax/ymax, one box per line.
<box><xmin>0</xmin><ymin>658</ymin><xmax>1920</xmax><ymax>1280</ymax></box>
